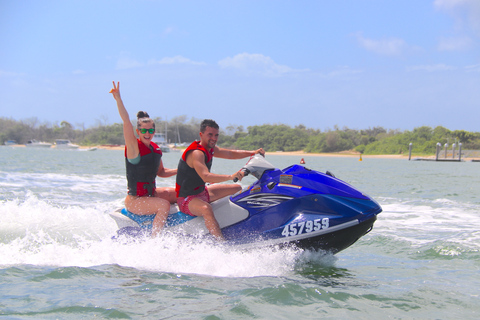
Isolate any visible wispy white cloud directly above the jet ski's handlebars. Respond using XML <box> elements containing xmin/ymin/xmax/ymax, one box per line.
<box><xmin>218</xmin><ymin>52</ymin><xmax>308</xmax><ymax>76</ymax></box>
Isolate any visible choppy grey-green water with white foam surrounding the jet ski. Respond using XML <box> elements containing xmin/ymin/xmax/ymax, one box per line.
<box><xmin>0</xmin><ymin>146</ymin><xmax>480</xmax><ymax>320</ymax></box>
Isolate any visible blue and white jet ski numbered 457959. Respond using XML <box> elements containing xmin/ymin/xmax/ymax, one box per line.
<box><xmin>110</xmin><ymin>155</ymin><xmax>382</xmax><ymax>254</ymax></box>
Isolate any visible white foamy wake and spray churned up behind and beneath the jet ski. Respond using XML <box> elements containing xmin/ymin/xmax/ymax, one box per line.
<box><xmin>0</xmin><ymin>194</ymin><xmax>315</xmax><ymax>277</ymax></box>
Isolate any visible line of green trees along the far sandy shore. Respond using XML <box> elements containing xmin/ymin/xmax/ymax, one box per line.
<box><xmin>0</xmin><ymin>116</ymin><xmax>480</xmax><ymax>154</ymax></box>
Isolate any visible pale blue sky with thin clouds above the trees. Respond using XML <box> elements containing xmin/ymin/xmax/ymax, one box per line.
<box><xmin>0</xmin><ymin>0</ymin><xmax>480</xmax><ymax>132</ymax></box>
